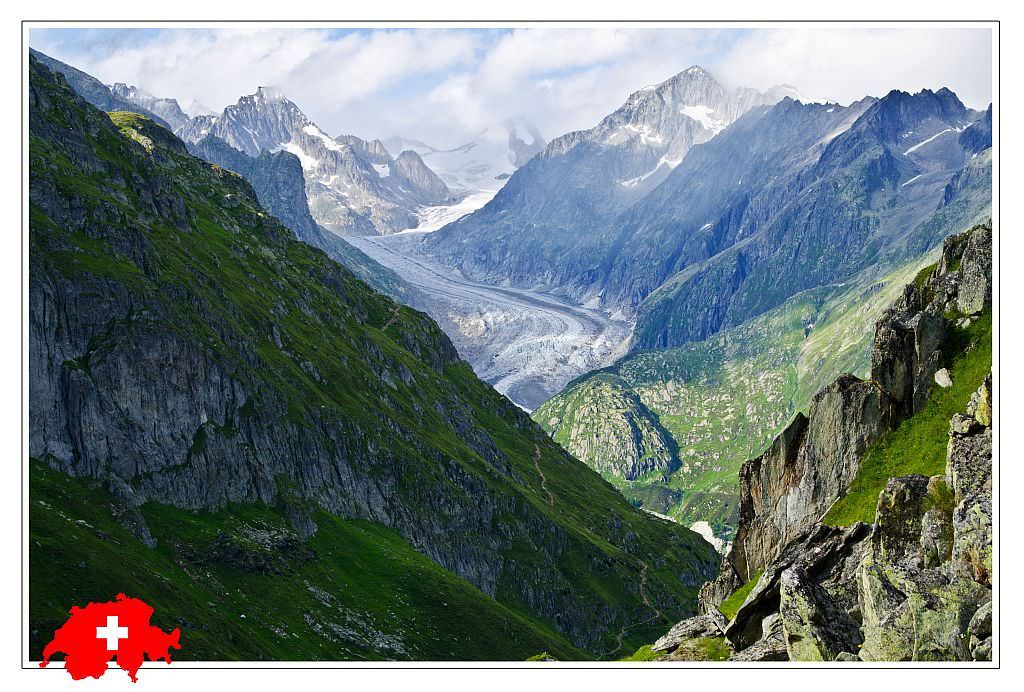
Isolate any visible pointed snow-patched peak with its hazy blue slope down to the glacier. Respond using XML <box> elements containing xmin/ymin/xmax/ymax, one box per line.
<box><xmin>429</xmin><ymin>66</ymin><xmax>794</xmax><ymax>288</ymax></box>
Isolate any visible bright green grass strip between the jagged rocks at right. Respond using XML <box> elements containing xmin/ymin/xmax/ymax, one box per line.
<box><xmin>824</xmin><ymin>310</ymin><xmax>992</xmax><ymax>526</ymax></box>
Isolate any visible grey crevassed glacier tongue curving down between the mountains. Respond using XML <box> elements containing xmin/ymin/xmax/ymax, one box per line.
<box><xmin>346</xmin><ymin>231</ymin><xmax>631</xmax><ymax>410</ymax></box>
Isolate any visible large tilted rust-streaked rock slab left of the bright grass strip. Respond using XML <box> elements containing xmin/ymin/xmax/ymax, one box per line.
<box><xmin>730</xmin><ymin>375</ymin><xmax>891</xmax><ymax>581</ymax></box>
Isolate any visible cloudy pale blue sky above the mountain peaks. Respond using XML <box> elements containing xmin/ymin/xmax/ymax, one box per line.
<box><xmin>30</xmin><ymin>27</ymin><xmax>992</xmax><ymax>146</ymax></box>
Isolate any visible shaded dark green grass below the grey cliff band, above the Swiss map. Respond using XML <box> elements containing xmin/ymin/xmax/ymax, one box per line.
<box><xmin>29</xmin><ymin>462</ymin><xmax>589</xmax><ymax>660</ymax></box>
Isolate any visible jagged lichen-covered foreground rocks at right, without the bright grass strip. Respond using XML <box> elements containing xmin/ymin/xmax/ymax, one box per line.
<box><xmin>671</xmin><ymin>226</ymin><xmax>992</xmax><ymax>660</ymax></box>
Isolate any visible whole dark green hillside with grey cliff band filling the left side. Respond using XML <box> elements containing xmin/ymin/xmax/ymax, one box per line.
<box><xmin>29</xmin><ymin>59</ymin><xmax>717</xmax><ymax>659</ymax></box>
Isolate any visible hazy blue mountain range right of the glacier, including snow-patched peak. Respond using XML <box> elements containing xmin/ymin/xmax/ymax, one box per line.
<box><xmin>424</xmin><ymin>68</ymin><xmax>990</xmax><ymax>349</ymax></box>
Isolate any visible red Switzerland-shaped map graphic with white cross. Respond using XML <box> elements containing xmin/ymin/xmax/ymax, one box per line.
<box><xmin>39</xmin><ymin>594</ymin><xmax>181</xmax><ymax>682</ymax></box>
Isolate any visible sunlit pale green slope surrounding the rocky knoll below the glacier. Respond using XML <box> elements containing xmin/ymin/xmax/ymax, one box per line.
<box><xmin>534</xmin><ymin>258</ymin><xmax>928</xmax><ymax>538</ymax></box>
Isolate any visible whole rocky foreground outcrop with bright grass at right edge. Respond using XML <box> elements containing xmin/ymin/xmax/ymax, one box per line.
<box><xmin>655</xmin><ymin>226</ymin><xmax>993</xmax><ymax>660</ymax></box>
